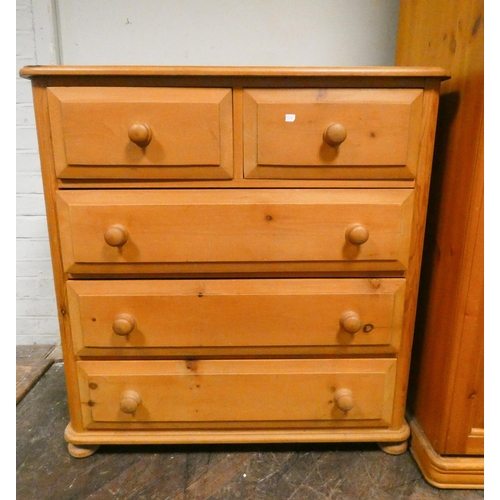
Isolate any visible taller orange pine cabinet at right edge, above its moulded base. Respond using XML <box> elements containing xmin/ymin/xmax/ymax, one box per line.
<box><xmin>396</xmin><ymin>0</ymin><xmax>484</xmax><ymax>455</ymax></box>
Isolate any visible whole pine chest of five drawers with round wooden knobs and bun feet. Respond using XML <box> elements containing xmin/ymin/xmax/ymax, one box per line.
<box><xmin>21</xmin><ymin>66</ymin><xmax>445</xmax><ymax>457</ymax></box>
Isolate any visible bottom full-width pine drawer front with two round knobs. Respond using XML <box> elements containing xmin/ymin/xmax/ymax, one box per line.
<box><xmin>77</xmin><ymin>359</ymin><xmax>396</xmax><ymax>428</ymax></box>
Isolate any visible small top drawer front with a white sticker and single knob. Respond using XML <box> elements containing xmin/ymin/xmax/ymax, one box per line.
<box><xmin>244</xmin><ymin>89</ymin><xmax>423</xmax><ymax>179</ymax></box>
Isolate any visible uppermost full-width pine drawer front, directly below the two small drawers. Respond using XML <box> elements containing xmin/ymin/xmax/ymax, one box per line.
<box><xmin>57</xmin><ymin>189</ymin><xmax>413</xmax><ymax>274</ymax></box>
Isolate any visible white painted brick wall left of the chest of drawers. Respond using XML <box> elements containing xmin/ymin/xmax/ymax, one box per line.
<box><xmin>16</xmin><ymin>0</ymin><xmax>60</xmax><ymax>345</ymax></box>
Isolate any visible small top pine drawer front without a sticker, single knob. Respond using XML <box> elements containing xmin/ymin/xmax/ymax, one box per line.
<box><xmin>48</xmin><ymin>87</ymin><xmax>233</xmax><ymax>179</ymax></box>
